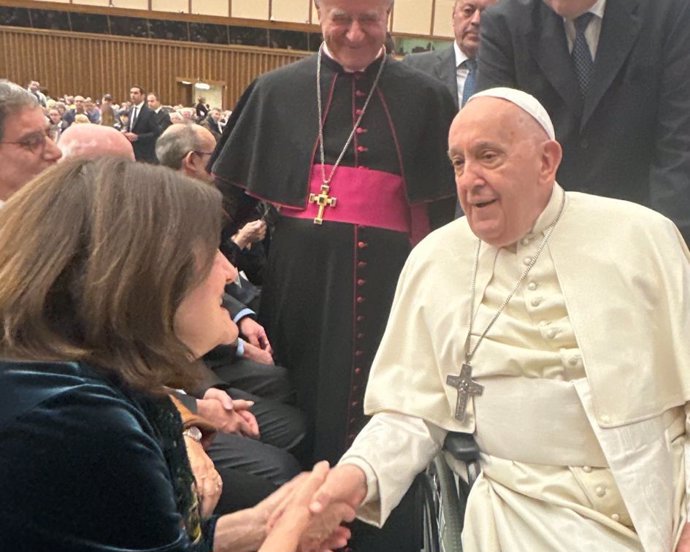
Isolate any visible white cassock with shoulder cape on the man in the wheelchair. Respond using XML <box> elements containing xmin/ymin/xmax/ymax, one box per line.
<box><xmin>341</xmin><ymin>185</ymin><xmax>690</xmax><ymax>552</ymax></box>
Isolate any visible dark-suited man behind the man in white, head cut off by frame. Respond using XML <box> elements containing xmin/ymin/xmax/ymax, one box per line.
<box><xmin>477</xmin><ymin>0</ymin><xmax>690</xmax><ymax>242</ymax></box>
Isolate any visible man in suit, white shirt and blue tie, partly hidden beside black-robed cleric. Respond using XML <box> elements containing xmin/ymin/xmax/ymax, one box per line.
<box><xmin>403</xmin><ymin>0</ymin><xmax>497</xmax><ymax>107</ymax></box>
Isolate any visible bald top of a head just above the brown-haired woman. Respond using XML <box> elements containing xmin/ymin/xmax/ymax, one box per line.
<box><xmin>58</xmin><ymin>125</ymin><xmax>134</xmax><ymax>161</ymax></box>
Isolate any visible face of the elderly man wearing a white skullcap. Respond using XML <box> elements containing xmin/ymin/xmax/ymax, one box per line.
<box><xmin>448</xmin><ymin>98</ymin><xmax>560</xmax><ymax>247</ymax></box>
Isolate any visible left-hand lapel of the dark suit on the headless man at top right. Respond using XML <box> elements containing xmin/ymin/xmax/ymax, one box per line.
<box><xmin>528</xmin><ymin>2</ymin><xmax>582</xmax><ymax>112</ymax></box>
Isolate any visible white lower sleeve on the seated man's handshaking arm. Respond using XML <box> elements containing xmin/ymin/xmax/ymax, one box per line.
<box><xmin>340</xmin><ymin>412</ymin><xmax>440</xmax><ymax>527</ymax></box>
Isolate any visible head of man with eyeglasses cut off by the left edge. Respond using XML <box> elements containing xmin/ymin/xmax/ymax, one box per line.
<box><xmin>0</xmin><ymin>80</ymin><xmax>62</xmax><ymax>207</ymax></box>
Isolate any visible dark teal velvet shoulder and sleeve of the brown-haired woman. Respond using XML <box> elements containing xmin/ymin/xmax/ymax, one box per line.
<box><xmin>0</xmin><ymin>362</ymin><xmax>188</xmax><ymax>552</ymax></box>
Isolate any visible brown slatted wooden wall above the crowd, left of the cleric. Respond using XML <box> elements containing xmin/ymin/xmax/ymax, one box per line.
<box><xmin>0</xmin><ymin>27</ymin><xmax>308</xmax><ymax>109</ymax></box>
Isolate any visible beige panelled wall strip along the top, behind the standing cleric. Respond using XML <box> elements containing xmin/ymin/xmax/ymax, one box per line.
<box><xmin>21</xmin><ymin>0</ymin><xmax>453</xmax><ymax>37</ymax></box>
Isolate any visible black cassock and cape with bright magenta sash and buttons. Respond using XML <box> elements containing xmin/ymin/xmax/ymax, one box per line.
<box><xmin>213</xmin><ymin>55</ymin><xmax>456</xmax><ymax>462</ymax></box>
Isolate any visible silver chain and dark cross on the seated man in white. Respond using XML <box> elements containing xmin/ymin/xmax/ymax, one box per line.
<box><xmin>446</xmin><ymin>194</ymin><xmax>565</xmax><ymax>422</ymax></box>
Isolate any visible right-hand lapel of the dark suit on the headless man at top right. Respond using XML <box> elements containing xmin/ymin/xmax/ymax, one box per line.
<box><xmin>582</xmin><ymin>0</ymin><xmax>642</xmax><ymax>126</ymax></box>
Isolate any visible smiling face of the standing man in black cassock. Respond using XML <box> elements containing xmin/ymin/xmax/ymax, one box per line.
<box><xmin>319</xmin><ymin>0</ymin><xmax>391</xmax><ymax>71</ymax></box>
